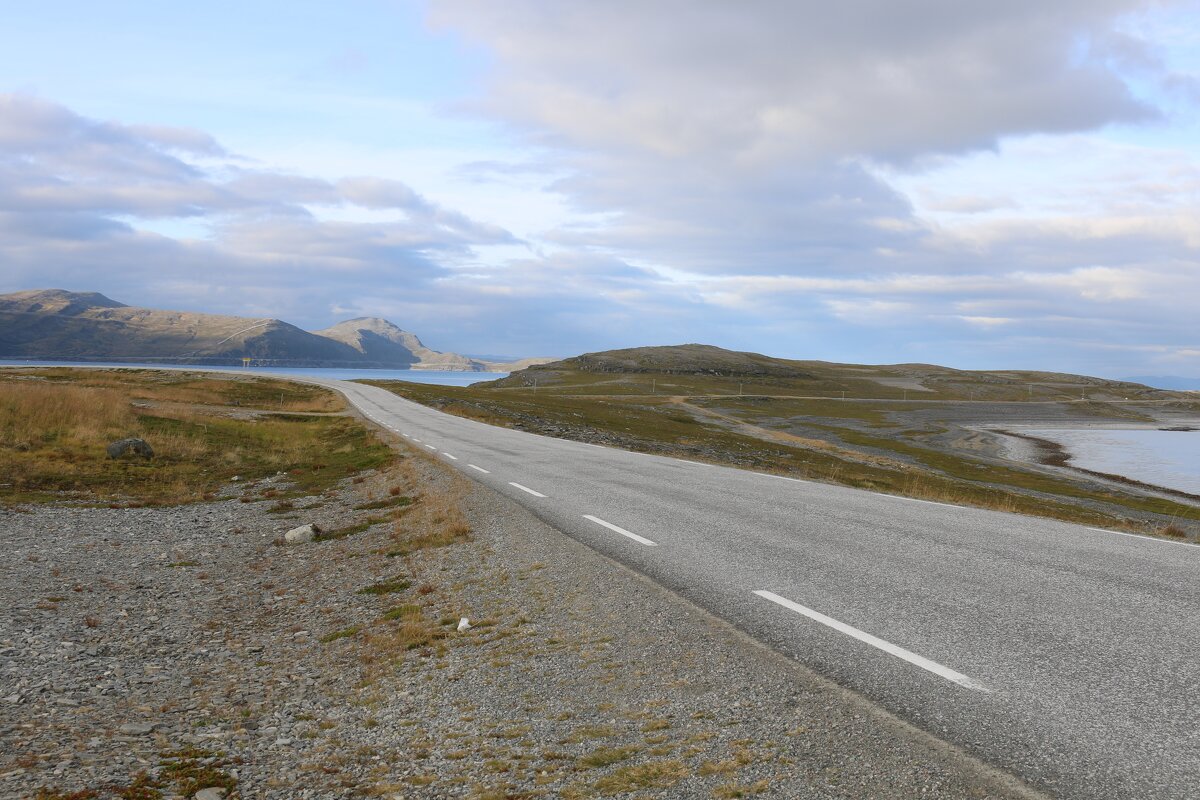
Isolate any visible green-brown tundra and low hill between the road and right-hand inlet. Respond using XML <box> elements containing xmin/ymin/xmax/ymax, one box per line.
<box><xmin>367</xmin><ymin>345</ymin><xmax>1200</xmax><ymax>537</ymax></box>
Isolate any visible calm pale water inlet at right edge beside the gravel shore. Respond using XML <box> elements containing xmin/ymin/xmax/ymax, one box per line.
<box><xmin>1030</xmin><ymin>428</ymin><xmax>1200</xmax><ymax>494</ymax></box>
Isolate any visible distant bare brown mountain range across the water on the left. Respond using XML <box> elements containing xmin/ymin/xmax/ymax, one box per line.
<box><xmin>0</xmin><ymin>289</ymin><xmax>540</xmax><ymax>372</ymax></box>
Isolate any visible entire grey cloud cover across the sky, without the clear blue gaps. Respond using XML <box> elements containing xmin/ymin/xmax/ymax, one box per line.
<box><xmin>0</xmin><ymin>0</ymin><xmax>1200</xmax><ymax>374</ymax></box>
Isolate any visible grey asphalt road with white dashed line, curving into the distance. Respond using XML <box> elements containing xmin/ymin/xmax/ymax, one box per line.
<box><xmin>326</xmin><ymin>381</ymin><xmax>1200</xmax><ymax>799</ymax></box>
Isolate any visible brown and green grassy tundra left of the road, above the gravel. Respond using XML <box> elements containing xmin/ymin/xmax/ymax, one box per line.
<box><xmin>0</xmin><ymin>368</ymin><xmax>392</xmax><ymax>510</ymax></box>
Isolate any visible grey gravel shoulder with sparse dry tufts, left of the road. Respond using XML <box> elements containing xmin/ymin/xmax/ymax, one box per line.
<box><xmin>0</xmin><ymin>441</ymin><xmax>1038</xmax><ymax>800</ymax></box>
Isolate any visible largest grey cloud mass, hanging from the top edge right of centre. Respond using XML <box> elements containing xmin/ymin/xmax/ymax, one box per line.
<box><xmin>431</xmin><ymin>0</ymin><xmax>1195</xmax><ymax>281</ymax></box>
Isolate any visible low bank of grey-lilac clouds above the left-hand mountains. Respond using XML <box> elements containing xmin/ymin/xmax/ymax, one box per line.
<box><xmin>0</xmin><ymin>95</ymin><xmax>516</xmax><ymax>321</ymax></box>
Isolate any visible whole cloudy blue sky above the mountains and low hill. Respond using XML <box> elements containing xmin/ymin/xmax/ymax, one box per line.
<box><xmin>0</xmin><ymin>0</ymin><xmax>1200</xmax><ymax>378</ymax></box>
